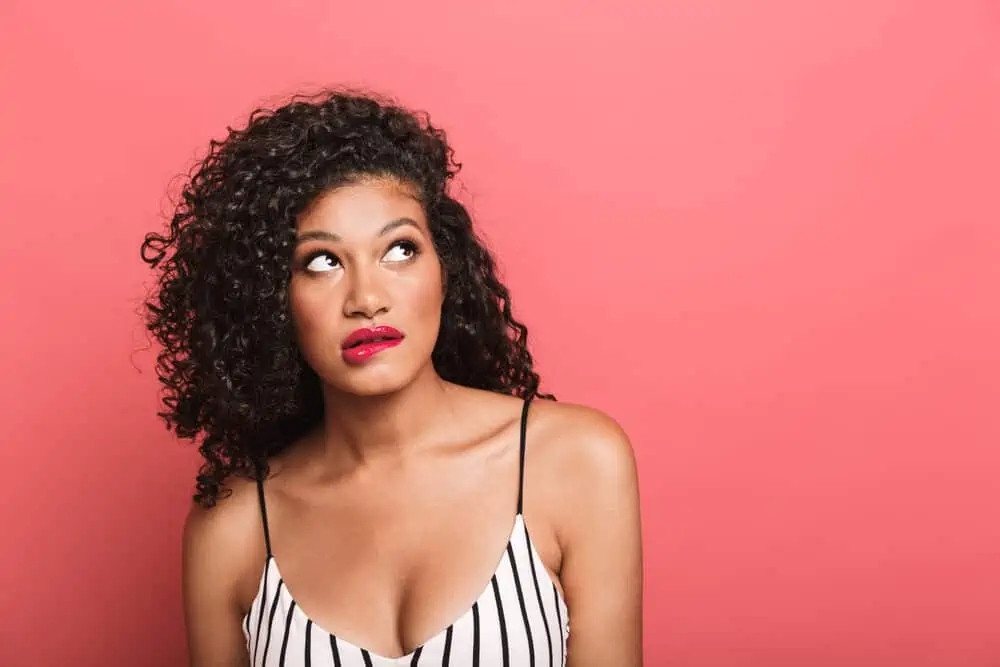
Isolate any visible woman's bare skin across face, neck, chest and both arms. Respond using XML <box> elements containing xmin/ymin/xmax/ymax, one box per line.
<box><xmin>183</xmin><ymin>179</ymin><xmax>642</xmax><ymax>667</ymax></box>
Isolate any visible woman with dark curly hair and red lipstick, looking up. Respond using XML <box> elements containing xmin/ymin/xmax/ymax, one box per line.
<box><xmin>143</xmin><ymin>92</ymin><xmax>642</xmax><ymax>667</ymax></box>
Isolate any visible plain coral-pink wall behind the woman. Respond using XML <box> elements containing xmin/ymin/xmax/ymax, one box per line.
<box><xmin>0</xmin><ymin>0</ymin><xmax>1000</xmax><ymax>667</ymax></box>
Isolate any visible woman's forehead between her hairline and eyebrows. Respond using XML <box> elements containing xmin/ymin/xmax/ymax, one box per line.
<box><xmin>296</xmin><ymin>178</ymin><xmax>427</xmax><ymax>240</ymax></box>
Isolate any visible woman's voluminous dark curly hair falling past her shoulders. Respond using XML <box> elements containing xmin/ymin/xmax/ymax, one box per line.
<box><xmin>142</xmin><ymin>90</ymin><xmax>551</xmax><ymax>507</ymax></box>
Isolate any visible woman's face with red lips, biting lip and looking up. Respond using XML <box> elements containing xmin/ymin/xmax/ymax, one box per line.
<box><xmin>289</xmin><ymin>179</ymin><xmax>444</xmax><ymax>396</ymax></box>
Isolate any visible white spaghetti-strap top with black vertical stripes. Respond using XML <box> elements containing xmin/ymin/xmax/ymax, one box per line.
<box><xmin>243</xmin><ymin>398</ymin><xmax>569</xmax><ymax>667</ymax></box>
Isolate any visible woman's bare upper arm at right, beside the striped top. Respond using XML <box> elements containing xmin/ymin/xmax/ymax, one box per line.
<box><xmin>559</xmin><ymin>408</ymin><xmax>642</xmax><ymax>667</ymax></box>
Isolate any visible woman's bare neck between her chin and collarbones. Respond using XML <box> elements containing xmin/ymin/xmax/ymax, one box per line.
<box><xmin>322</xmin><ymin>367</ymin><xmax>450</xmax><ymax>466</ymax></box>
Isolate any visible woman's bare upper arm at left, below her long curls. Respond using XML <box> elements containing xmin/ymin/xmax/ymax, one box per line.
<box><xmin>182</xmin><ymin>490</ymin><xmax>260</xmax><ymax>667</ymax></box>
